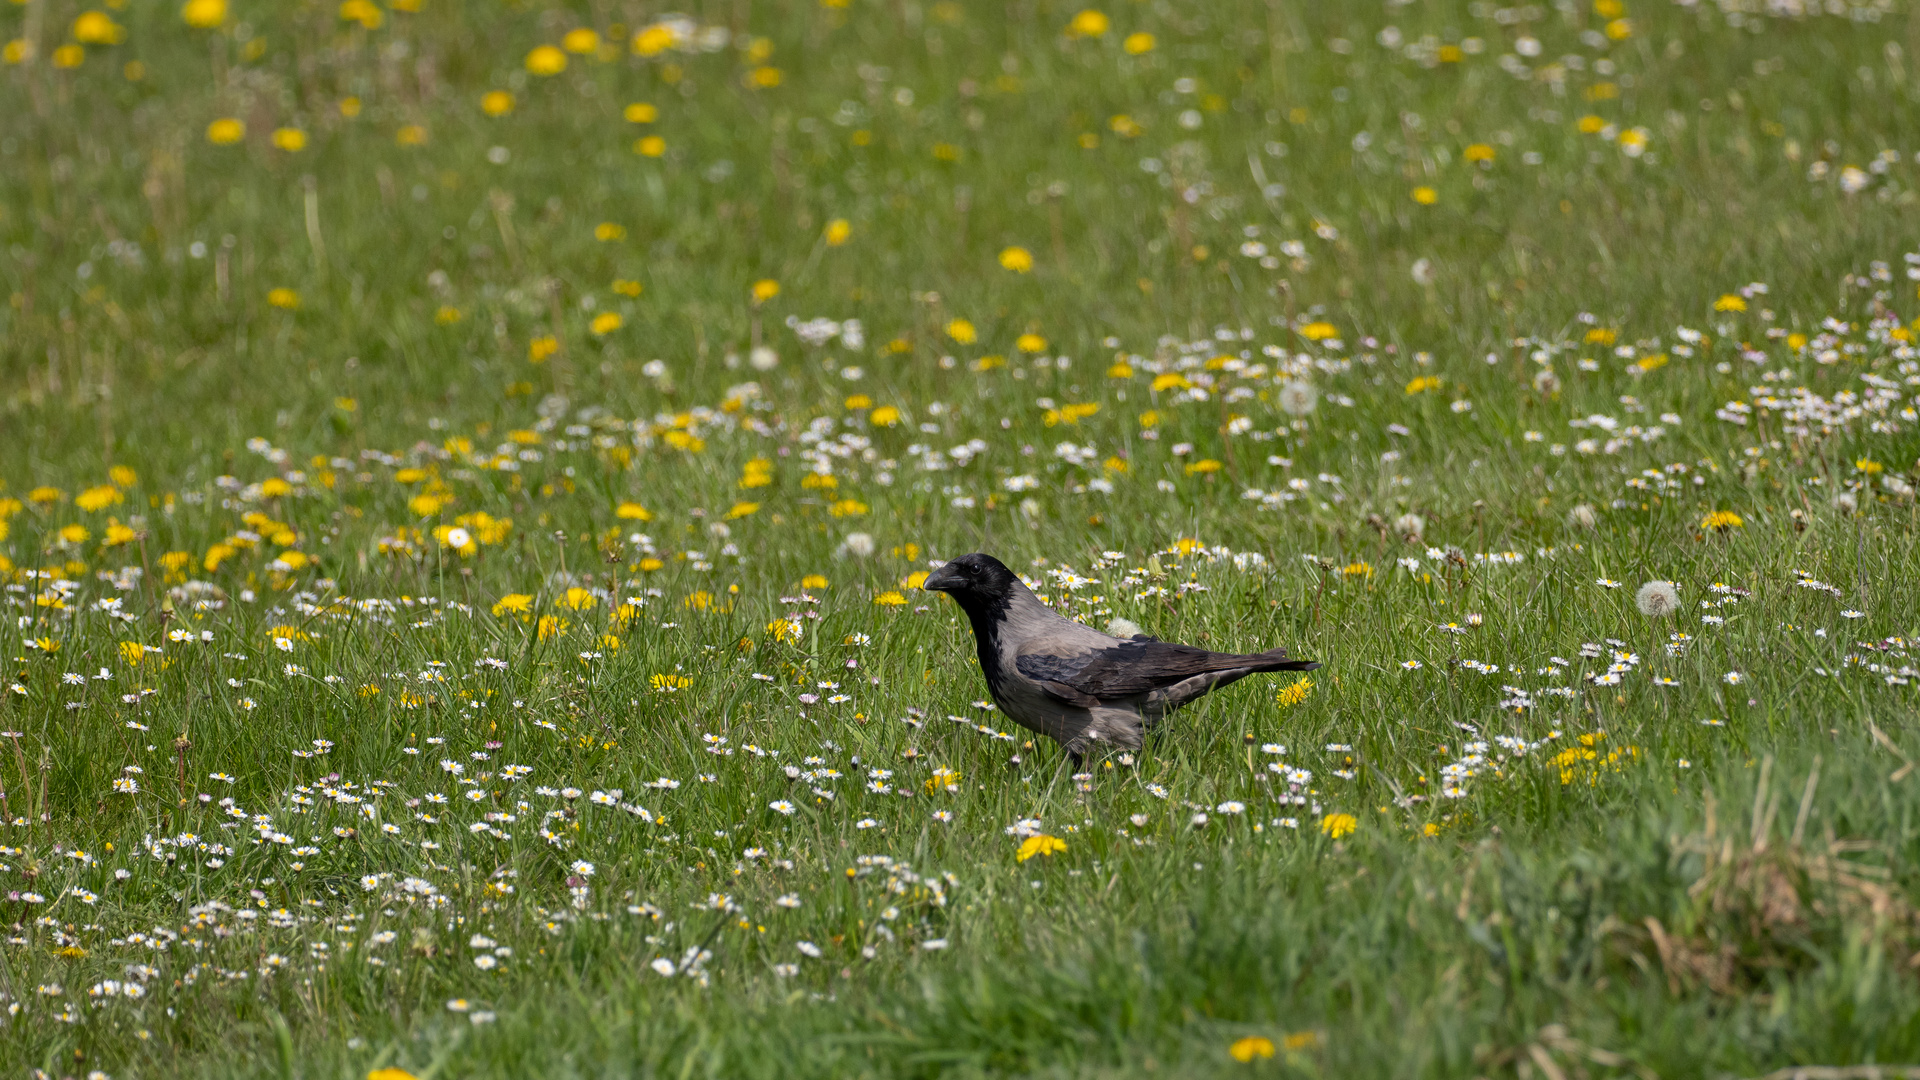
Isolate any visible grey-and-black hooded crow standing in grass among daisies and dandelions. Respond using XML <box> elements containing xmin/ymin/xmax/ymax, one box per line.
<box><xmin>922</xmin><ymin>553</ymin><xmax>1319</xmax><ymax>761</ymax></box>
